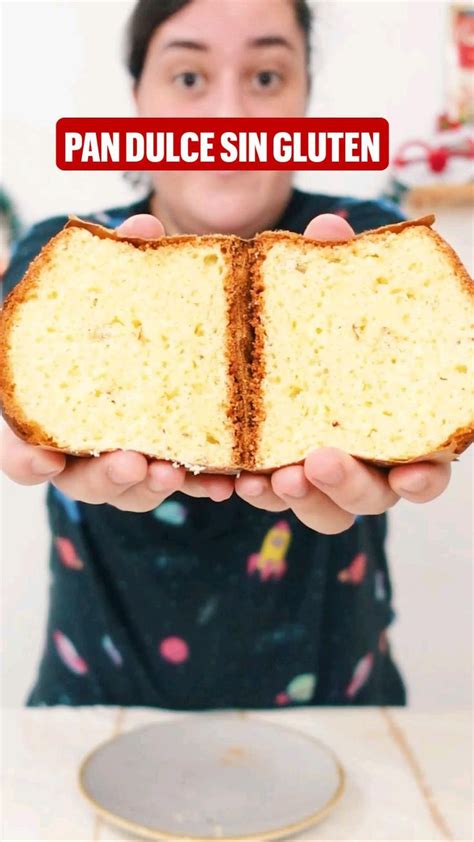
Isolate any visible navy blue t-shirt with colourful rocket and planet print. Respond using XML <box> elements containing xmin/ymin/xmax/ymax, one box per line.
<box><xmin>4</xmin><ymin>190</ymin><xmax>405</xmax><ymax>710</ymax></box>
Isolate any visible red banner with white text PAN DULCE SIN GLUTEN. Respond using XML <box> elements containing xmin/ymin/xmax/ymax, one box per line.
<box><xmin>56</xmin><ymin>117</ymin><xmax>389</xmax><ymax>170</ymax></box>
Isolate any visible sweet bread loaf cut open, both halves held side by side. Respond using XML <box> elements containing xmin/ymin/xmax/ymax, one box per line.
<box><xmin>0</xmin><ymin>217</ymin><xmax>474</xmax><ymax>473</ymax></box>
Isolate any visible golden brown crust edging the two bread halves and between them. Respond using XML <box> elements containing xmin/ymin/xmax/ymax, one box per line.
<box><xmin>0</xmin><ymin>215</ymin><xmax>474</xmax><ymax>474</ymax></box>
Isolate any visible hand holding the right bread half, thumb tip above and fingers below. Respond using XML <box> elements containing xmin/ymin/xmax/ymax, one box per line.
<box><xmin>235</xmin><ymin>214</ymin><xmax>451</xmax><ymax>535</ymax></box>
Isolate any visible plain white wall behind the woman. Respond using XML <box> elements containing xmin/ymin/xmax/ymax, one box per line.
<box><xmin>2</xmin><ymin>0</ymin><xmax>472</xmax><ymax>707</ymax></box>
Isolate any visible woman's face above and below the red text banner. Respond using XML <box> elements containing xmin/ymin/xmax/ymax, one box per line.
<box><xmin>136</xmin><ymin>0</ymin><xmax>307</xmax><ymax>237</ymax></box>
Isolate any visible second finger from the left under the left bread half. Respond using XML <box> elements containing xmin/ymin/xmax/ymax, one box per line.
<box><xmin>54</xmin><ymin>451</ymin><xmax>148</xmax><ymax>504</ymax></box>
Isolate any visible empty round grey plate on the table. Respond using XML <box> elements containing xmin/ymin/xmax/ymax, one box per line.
<box><xmin>79</xmin><ymin>712</ymin><xmax>344</xmax><ymax>842</ymax></box>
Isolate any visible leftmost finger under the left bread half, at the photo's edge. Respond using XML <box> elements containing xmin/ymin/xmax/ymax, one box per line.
<box><xmin>1</xmin><ymin>424</ymin><xmax>66</xmax><ymax>485</ymax></box>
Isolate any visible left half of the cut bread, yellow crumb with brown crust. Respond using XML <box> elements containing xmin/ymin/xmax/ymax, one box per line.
<box><xmin>2</xmin><ymin>225</ymin><xmax>252</xmax><ymax>470</ymax></box>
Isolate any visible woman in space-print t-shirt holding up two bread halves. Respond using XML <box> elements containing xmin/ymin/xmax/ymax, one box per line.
<box><xmin>4</xmin><ymin>0</ymin><xmax>450</xmax><ymax>709</ymax></box>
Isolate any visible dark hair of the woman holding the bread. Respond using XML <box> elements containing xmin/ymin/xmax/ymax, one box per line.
<box><xmin>126</xmin><ymin>0</ymin><xmax>313</xmax><ymax>82</ymax></box>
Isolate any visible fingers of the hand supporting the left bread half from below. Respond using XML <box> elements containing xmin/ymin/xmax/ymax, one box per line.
<box><xmin>2</xmin><ymin>424</ymin><xmax>234</xmax><ymax>512</ymax></box>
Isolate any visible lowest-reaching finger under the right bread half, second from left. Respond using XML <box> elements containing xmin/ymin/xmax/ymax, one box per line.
<box><xmin>272</xmin><ymin>466</ymin><xmax>355</xmax><ymax>535</ymax></box>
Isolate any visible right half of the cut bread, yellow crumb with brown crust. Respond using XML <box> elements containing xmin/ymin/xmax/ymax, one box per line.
<box><xmin>252</xmin><ymin>224</ymin><xmax>474</xmax><ymax>468</ymax></box>
